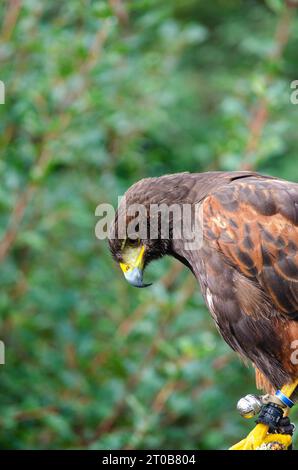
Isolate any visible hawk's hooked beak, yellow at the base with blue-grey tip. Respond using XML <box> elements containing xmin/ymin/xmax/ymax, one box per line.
<box><xmin>119</xmin><ymin>245</ymin><xmax>151</xmax><ymax>287</ymax></box>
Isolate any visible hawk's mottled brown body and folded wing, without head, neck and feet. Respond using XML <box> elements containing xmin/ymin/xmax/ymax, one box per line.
<box><xmin>199</xmin><ymin>178</ymin><xmax>298</xmax><ymax>389</ymax></box>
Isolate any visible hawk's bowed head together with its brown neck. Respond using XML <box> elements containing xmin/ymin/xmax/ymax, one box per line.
<box><xmin>109</xmin><ymin>172</ymin><xmax>222</xmax><ymax>287</ymax></box>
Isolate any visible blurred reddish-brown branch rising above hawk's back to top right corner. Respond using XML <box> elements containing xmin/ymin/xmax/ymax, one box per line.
<box><xmin>241</xmin><ymin>2</ymin><xmax>298</xmax><ymax>170</ymax></box>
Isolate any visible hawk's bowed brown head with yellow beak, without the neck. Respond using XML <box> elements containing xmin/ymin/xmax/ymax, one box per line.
<box><xmin>109</xmin><ymin>175</ymin><xmax>187</xmax><ymax>287</ymax></box>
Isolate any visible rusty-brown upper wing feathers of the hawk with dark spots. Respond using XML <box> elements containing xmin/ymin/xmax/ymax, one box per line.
<box><xmin>203</xmin><ymin>178</ymin><xmax>298</xmax><ymax>318</ymax></box>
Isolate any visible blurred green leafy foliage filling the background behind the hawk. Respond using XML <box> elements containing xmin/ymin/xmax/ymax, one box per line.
<box><xmin>0</xmin><ymin>0</ymin><xmax>298</xmax><ymax>449</ymax></box>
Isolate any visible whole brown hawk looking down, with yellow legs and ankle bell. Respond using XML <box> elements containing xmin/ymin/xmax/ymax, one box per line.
<box><xmin>109</xmin><ymin>171</ymin><xmax>298</xmax><ymax>449</ymax></box>
